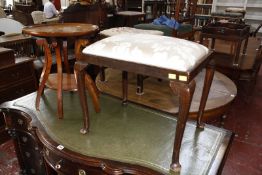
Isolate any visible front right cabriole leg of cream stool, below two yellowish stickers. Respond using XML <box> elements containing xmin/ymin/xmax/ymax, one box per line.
<box><xmin>170</xmin><ymin>80</ymin><xmax>196</xmax><ymax>172</ymax></box>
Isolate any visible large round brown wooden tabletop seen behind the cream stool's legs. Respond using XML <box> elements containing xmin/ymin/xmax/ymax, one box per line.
<box><xmin>96</xmin><ymin>68</ymin><xmax>237</xmax><ymax>121</ymax></box>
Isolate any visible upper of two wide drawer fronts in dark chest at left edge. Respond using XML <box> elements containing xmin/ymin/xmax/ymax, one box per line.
<box><xmin>0</xmin><ymin>62</ymin><xmax>34</xmax><ymax>87</ymax></box>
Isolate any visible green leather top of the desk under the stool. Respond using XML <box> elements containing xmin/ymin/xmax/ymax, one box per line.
<box><xmin>10</xmin><ymin>89</ymin><xmax>231</xmax><ymax>175</ymax></box>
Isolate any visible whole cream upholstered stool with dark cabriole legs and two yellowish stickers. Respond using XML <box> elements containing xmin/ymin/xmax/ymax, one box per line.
<box><xmin>75</xmin><ymin>34</ymin><xmax>214</xmax><ymax>172</ymax></box>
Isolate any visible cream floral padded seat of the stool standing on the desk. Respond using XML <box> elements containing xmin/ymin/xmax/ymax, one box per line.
<box><xmin>83</xmin><ymin>34</ymin><xmax>209</xmax><ymax>72</ymax></box>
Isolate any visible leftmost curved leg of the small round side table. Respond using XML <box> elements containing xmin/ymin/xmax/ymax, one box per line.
<box><xmin>35</xmin><ymin>40</ymin><xmax>52</xmax><ymax>110</ymax></box>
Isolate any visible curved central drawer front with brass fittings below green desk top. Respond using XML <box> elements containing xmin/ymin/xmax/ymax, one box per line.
<box><xmin>44</xmin><ymin>148</ymin><xmax>106</xmax><ymax>175</ymax></box>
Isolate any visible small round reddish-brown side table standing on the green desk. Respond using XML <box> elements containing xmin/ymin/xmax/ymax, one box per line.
<box><xmin>23</xmin><ymin>23</ymin><xmax>98</xmax><ymax>118</ymax></box>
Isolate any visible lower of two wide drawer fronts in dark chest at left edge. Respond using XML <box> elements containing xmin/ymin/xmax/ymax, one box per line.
<box><xmin>0</xmin><ymin>78</ymin><xmax>36</xmax><ymax>103</ymax></box>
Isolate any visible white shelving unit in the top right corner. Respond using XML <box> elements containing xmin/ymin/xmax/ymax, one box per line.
<box><xmin>212</xmin><ymin>0</ymin><xmax>262</xmax><ymax>33</ymax></box>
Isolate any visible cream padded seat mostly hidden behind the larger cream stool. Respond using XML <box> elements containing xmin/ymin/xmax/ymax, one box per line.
<box><xmin>100</xmin><ymin>27</ymin><xmax>164</xmax><ymax>37</ymax></box>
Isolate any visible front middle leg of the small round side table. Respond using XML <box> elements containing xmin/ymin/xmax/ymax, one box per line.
<box><xmin>52</xmin><ymin>41</ymin><xmax>63</xmax><ymax>119</ymax></box>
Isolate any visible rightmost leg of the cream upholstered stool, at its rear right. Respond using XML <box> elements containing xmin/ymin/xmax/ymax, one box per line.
<box><xmin>197</xmin><ymin>67</ymin><xmax>215</xmax><ymax>128</ymax></box>
